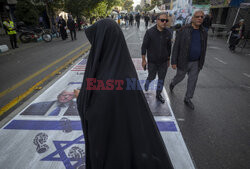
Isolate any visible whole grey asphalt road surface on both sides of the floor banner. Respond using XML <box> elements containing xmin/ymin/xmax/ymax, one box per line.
<box><xmin>0</xmin><ymin>23</ymin><xmax>250</xmax><ymax>169</ymax></box>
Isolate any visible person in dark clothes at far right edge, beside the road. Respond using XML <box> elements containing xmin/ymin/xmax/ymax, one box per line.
<box><xmin>229</xmin><ymin>19</ymin><xmax>245</xmax><ymax>52</ymax></box>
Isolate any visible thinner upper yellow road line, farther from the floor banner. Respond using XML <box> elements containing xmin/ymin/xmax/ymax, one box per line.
<box><xmin>0</xmin><ymin>43</ymin><xmax>88</xmax><ymax>98</ymax></box>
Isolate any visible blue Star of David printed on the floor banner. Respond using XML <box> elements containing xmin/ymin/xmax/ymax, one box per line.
<box><xmin>41</xmin><ymin>135</ymin><xmax>85</xmax><ymax>169</ymax></box>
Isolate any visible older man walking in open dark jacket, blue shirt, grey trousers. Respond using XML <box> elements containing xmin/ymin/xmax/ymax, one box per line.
<box><xmin>169</xmin><ymin>10</ymin><xmax>207</xmax><ymax>109</ymax></box>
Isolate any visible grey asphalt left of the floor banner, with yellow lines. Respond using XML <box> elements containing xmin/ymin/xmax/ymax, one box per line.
<box><xmin>0</xmin><ymin>31</ymin><xmax>89</xmax><ymax>120</ymax></box>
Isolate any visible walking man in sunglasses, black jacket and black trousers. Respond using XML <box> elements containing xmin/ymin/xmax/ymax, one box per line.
<box><xmin>141</xmin><ymin>13</ymin><xmax>172</xmax><ymax>103</ymax></box>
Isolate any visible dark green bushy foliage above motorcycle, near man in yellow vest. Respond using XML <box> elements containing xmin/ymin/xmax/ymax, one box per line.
<box><xmin>15</xmin><ymin>0</ymin><xmax>38</xmax><ymax>25</ymax></box>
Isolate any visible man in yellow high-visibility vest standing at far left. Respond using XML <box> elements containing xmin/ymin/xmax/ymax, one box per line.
<box><xmin>3</xmin><ymin>16</ymin><xmax>18</xmax><ymax>49</ymax></box>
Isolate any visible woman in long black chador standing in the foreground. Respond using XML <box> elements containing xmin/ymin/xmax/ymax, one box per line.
<box><xmin>77</xmin><ymin>19</ymin><xmax>173</xmax><ymax>169</ymax></box>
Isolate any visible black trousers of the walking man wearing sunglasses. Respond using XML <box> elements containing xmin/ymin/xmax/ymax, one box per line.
<box><xmin>145</xmin><ymin>62</ymin><xmax>168</xmax><ymax>95</ymax></box>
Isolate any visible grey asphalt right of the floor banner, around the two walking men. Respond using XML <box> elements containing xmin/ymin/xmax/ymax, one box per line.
<box><xmin>123</xmin><ymin>23</ymin><xmax>250</xmax><ymax>169</ymax></box>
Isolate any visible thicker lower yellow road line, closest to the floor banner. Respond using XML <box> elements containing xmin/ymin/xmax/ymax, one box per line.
<box><xmin>0</xmin><ymin>46</ymin><xmax>90</xmax><ymax>116</ymax></box>
